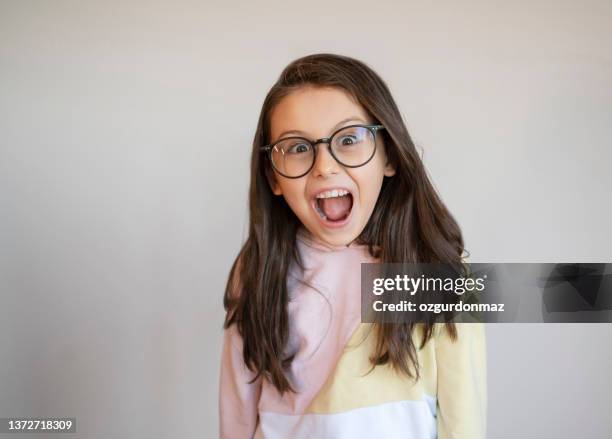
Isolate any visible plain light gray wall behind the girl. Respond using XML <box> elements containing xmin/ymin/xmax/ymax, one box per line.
<box><xmin>0</xmin><ymin>0</ymin><xmax>612</xmax><ymax>438</ymax></box>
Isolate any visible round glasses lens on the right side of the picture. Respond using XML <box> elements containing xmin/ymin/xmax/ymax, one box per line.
<box><xmin>332</xmin><ymin>127</ymin><xmax>376</xmax><ymax>166</ymax></box>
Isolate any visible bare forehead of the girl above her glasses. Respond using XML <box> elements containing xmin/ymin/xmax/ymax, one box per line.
<box><xmin>270</xmin><ymin>87</ymin><xmax>369</xmax><ymax>139</ymax></box>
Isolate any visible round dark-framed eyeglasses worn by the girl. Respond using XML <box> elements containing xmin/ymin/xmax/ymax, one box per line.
<box><xmin>260</xmin><ymin>125</ymin><xmax>385</xmax><ymax>178</ymax></box>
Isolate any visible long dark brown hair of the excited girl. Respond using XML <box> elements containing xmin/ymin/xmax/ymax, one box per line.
<box><xmin>223</xmin><ymin>54</ymin><xmax>464</xmax><ymax>394</ymax></box>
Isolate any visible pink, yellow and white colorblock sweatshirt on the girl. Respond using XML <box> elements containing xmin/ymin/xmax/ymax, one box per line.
<box><xmin>219</xmin><ymin>228</ymin><xmax>487</xmax><ymax>439</ymax></box>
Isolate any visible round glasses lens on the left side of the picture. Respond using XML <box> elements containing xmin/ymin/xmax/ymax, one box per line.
<box><xmin>272</xmin><ymin>137</ymin><xmax>315</xmax><ymax>177</ymax></box>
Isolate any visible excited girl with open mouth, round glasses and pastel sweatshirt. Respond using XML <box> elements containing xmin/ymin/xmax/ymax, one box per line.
<box><xmin>219</xmin><ymin>54</ymin><xmax>486</xmax><ymax>439</ymax></box>
